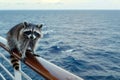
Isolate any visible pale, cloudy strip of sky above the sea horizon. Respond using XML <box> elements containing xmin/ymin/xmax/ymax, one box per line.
<box><xmin>0</xmin><ymin>0</ymin><xmax>120</xmax><ymax>10</ymax></box>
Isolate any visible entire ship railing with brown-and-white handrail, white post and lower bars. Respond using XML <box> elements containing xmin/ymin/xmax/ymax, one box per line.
<box><xmin>0</xmin><ymin>36</ymin><xmax>84</xmax><ymax>80</ymax></box>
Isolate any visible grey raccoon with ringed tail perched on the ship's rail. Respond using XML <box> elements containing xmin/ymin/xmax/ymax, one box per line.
<box><xmin>7</xmin><ymin>22</ymin><xmax>43</xmax><ymax>70</ymax></box>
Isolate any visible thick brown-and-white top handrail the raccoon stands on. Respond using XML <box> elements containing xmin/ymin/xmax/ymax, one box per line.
<box><xmin>0</xmin><ymin>36</ymin><xmax>84</xmax><ymax>80</ymax></box>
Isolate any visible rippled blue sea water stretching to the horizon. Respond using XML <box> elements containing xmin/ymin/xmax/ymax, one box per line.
<box><xmin>0</xmin><ymin>10</ymin><xmax>120</xmax><ymax>80</ymax></box>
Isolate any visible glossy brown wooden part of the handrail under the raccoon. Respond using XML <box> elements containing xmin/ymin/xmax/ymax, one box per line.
<box><xmin>0</xmin><ymin>42</ymin><xmax>58</xmax><ymax>80</ymax></box>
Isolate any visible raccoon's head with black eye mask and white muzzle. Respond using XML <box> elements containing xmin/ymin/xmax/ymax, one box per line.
<box><xmin>23</xmin><ymin>23</ymin><xmax>42</xmax><ymax>40</ymax></box>
